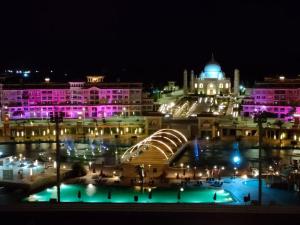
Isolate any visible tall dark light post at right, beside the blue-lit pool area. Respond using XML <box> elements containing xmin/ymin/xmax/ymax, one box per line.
<box><xmin>254</xmin><ymin>112</ymin><xmax>267</xmax><ymax>205</ymax></box>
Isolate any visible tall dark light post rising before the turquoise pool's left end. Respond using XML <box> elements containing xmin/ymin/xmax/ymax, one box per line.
<box><xmin>50</xmin><ymin>112</ymin><xmax>63</xmax><ymax>204</ymax></box>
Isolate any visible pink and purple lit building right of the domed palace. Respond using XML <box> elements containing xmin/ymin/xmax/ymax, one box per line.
<box><xmin>243</xmin><ymin>76</ymin><xmax>300</xmax><ymax>121</ymax></box>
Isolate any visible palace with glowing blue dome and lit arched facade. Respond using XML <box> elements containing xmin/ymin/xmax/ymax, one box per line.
<box><xmin>184</xmin><ymin>56</ymin><xmax>231</xmax><ymax>95</ymax></box>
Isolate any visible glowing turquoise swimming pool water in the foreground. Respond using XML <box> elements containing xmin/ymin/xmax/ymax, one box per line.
<box><xmin>24</xmin><ymin>184</ymin><xmax>234</xmax><ymax>203</ymax></box>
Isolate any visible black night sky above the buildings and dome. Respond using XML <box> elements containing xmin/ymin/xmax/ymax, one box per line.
<box><xmin>0</xmin><ymin>0</ymin><xmax>300</xmax><ymax>83</ymax></box>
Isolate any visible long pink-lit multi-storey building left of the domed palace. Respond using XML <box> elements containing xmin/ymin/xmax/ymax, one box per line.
<box><xmin>0</xmin><ymin>76</ymin><xmax>153</xmax><ymax>120</ymax></box>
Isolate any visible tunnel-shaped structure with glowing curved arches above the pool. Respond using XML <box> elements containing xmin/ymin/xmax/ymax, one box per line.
<box><xmin>121</xmin><ymin>129</ymin><xmax>187</xmax><ymax>164</ymax></box>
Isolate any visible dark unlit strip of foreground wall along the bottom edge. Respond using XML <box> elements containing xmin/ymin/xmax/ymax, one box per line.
<box><xmin>0</xmin><ymin>203</ymin><xmax>300</xmax><ymax>225</ymax></box>
